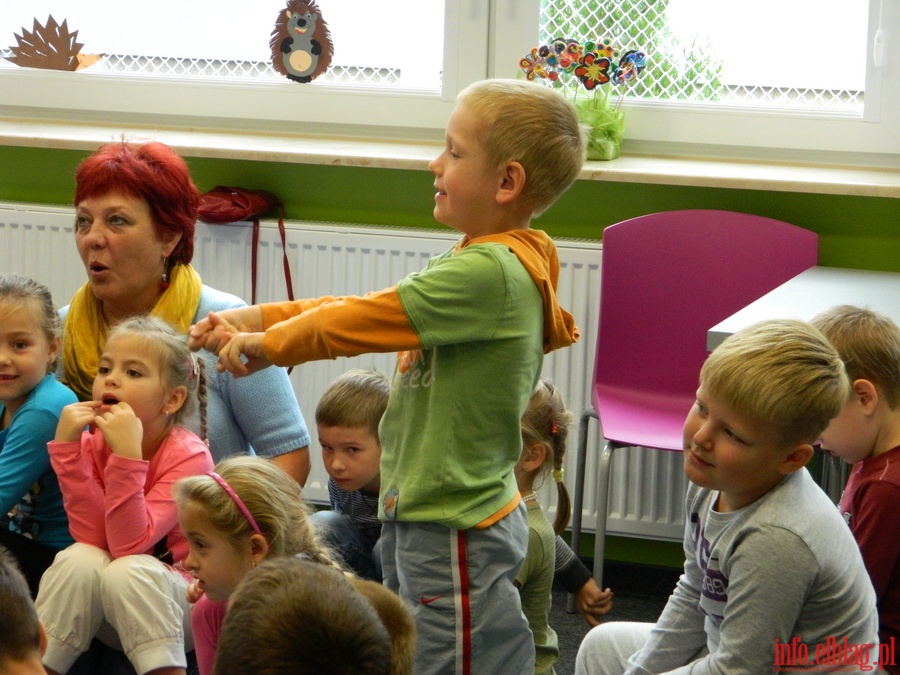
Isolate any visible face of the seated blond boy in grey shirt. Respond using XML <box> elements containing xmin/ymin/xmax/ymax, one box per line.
<box><xmin>684</xmin><ymin>384</ymin><xmax>790</xmax><ymax>512</ymax></box>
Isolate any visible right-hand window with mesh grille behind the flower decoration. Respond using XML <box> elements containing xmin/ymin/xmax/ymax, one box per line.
<box><xmin>540</xmin><ymin>0</ymin><xmax>900</xmax><ymax>163</ymax></box>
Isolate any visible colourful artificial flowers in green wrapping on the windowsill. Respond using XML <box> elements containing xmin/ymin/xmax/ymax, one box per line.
<box><xmin>519</xmin><ymin>38</ymin><xmax>647</xmax><ymax>159</ymax></box>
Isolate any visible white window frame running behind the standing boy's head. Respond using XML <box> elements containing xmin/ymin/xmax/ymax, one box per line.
<box><xmin>0</xmin><ymin>0</ymin><xmax>900</xmax><ymax>160</ymax></box>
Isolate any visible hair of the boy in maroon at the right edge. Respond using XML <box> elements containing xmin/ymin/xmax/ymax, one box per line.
<box><xmin>812</xmin><ymin>305</ymin><xmax>900</xmax><ymax>409</ymax></box>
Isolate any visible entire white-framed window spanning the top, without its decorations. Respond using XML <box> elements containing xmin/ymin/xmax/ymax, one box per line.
<box><xmin>0</xmin><ymin>0</ymin><xmax>900</xmax><ymax>160</ymax></box>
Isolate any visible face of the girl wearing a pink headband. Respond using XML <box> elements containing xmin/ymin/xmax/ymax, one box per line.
<box><xmin>178</xmin><ymin>501</ymin><xmax>253</xmax><ymax>602</ymax></box>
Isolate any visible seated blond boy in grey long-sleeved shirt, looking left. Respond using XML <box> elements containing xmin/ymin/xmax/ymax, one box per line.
<box><xmin>575</xmin><ymin>320</ymin><xmax>878</xmax><ymax>675</ymax></box>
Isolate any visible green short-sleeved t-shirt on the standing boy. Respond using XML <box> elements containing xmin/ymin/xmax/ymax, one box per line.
<box><xmin>379</xmin><ymin>243</ymin><xmax>544</xmax><ymax>529</ymax></box>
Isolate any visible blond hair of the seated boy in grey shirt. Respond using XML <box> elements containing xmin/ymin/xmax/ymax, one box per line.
<box><xmin>700</xmin><ymin>319</ymin><xmax>849</xmax><ymax>445</ymax></box>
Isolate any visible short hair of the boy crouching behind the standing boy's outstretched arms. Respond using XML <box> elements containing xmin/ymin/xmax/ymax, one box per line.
<box><xmin>316</xmin><ymin>368</ymin><xmax>391</xmax><ymax>438</ymax></box>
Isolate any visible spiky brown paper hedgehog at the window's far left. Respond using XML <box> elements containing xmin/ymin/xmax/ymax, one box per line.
<box><xmin>6</xmin><ymin>16</ymin><xmax>100</xmax><ymax>71</ymax></box>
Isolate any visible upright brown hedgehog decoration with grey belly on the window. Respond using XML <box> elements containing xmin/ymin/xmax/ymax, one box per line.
<box><xmin>269</xmin><ymin>0</ymin><xmax>334</xmax><ymax>84</ymax></box>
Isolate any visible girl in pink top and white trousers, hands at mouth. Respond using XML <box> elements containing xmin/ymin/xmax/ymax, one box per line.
<box><xmin>36</xmin><ymin>316</ymin><xmax>213</xmax><ymax>675</ymax></box>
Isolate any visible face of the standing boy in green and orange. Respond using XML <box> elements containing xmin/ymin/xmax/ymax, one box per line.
<box><xmin>428</xmin><ymin>100</ymin><xmax>501</xmax><ymax>237</ymax></box>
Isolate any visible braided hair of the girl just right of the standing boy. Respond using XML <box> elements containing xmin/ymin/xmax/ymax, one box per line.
<box><xmin>520</xmin><ymin>380</ymin><xmax>572</xmax><ymax>534</ymax></box>
